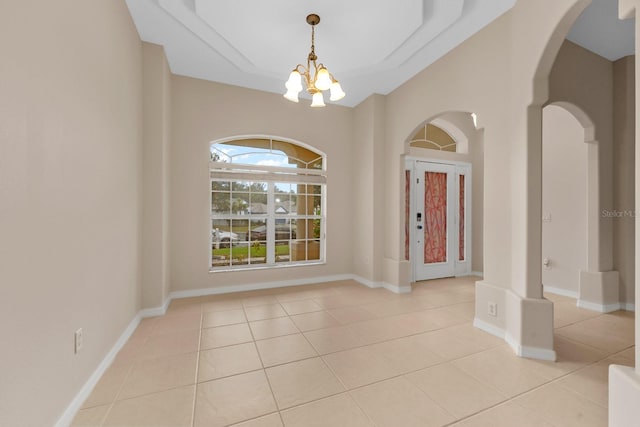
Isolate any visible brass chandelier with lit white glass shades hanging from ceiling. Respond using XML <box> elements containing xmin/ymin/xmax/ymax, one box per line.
<box><xmin>284</xmin><ymin>13</ymin><xmax>345</xmax><ymax>107</ymax></box>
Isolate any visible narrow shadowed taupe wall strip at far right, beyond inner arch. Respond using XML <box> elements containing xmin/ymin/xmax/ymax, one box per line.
<box><xmin>613</xmin><ymin>56</ymin><xmax>636</xmax><ymax>304</ymax></box>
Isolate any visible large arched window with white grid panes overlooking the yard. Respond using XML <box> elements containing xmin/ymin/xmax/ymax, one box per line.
<box><xmin>210</xmin><ymin>137</ymin><xmax>326</xmax><ymax>271</ymax></box>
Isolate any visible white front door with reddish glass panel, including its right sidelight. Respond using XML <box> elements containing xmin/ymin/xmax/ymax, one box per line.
<box><xmin>412</xmin><ymin>161</ymin><xmax>470</xmax><ymax>281</ymax></box>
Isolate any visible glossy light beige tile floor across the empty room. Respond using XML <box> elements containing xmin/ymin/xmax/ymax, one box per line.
<box><xmin>73</xmin><ymin>277</ymin><xmax>634</xmax><ymax>427</ymax></box>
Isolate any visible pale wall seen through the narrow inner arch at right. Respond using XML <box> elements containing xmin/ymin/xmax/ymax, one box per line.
<box><xmin>542</xmin><ymin>105</ymin><xmax>588</xmax><ymax>296</ymax></box>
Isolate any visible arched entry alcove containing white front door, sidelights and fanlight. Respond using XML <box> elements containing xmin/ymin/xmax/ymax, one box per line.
<box><xmin>404</xmin><ymin>112</ymin><xmax>484</xmax><ymax>282</ymax></box>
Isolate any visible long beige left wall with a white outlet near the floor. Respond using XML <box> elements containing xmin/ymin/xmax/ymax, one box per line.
<box><xmin>0</xmin><ymin>0</ymin><xmax>142</xmax><ymax>426</ymax></box>
